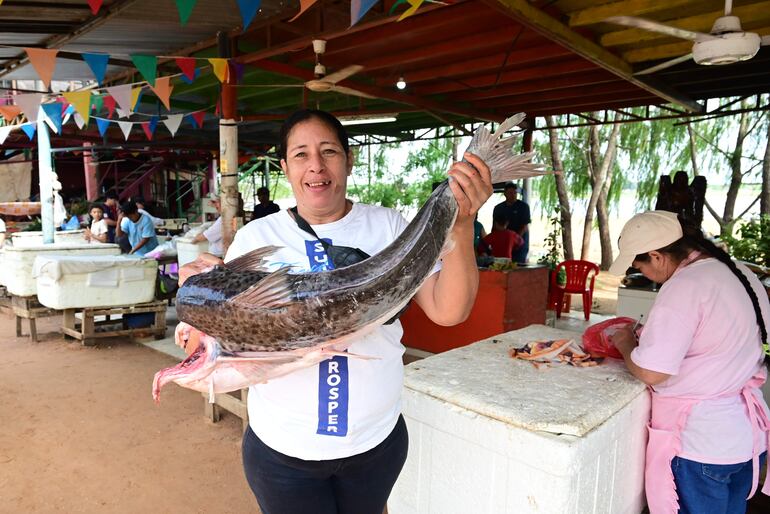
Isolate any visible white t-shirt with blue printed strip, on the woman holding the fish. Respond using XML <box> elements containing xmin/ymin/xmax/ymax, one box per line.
<box><xmin>225</xmin><ymin>204</ymin><xmax>440</xmax><ymax>460</ymax></box>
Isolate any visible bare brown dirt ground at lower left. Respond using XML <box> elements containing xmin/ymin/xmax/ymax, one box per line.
<box><xmin>0</xmin><ymin>311</ymin><xmax>259</xmax><ymax>513</ymax></box>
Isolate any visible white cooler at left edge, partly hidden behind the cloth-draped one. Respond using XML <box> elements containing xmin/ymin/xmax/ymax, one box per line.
<box><xmin>0</xmin><ymin>242</ymin><xmax>120</xmax><ymax>296</ymax></box>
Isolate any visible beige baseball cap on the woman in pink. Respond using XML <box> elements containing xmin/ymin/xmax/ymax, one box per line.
<box><xmin>609</xmin><ymin>211</ymin><xmax>683</xmax><ymax>275</ymax></box>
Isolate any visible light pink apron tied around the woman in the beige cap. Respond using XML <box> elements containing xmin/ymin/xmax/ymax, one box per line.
<box><xmin>644</xmin><ymin>369</ymin><xmax>770</xmax><ymax>514</ymax></box>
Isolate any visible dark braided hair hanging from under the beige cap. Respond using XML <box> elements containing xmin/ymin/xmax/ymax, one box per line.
<box><xmin>634</xmin><ymin>216</ymin><xmax>770</xmax><ymax>367</ymax></box>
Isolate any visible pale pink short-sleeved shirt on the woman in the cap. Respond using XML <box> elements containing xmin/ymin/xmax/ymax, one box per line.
<box><xmin>631</xmin><ymin>258</ymin><xmax>770</xmax><ymax>464</ymax></box>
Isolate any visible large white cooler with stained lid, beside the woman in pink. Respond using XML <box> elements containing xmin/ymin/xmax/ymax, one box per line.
<box><xmin>388</xmin><ymin>325</ymin><xmax>650</xmax><ymax>514</ymax></box>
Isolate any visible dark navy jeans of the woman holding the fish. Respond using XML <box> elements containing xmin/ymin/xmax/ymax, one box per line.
<box><xmin>243</xmin><ymin>416</ymin><xmax>409</xmax><ymax>514</ymax></box>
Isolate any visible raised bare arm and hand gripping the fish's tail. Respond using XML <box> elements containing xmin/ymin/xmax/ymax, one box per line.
<box><xmin>415</xmin><ymin>153</ymin><xmax>492</xmax><ymax>326</ymax></box>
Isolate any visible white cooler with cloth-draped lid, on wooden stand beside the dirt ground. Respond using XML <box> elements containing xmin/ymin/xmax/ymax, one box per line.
<box><xmin>32</xmin><ymin>255</ymin><xmax>158</xmax><ymax>309</ymax></box>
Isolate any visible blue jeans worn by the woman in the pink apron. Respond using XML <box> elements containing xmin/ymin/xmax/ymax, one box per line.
<box><xmin>671</xmin><ymin>452</ymin><xmax>767</xmax><ymax>514</ymax></box>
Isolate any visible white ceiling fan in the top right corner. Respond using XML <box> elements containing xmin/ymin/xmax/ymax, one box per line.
<box><xmin>604</xmin><ymin>0</ymin><xmax>770</xmax><ymax>75</ymax></box>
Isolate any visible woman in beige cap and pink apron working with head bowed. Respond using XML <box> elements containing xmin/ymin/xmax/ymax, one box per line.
<box><xmin>610</xmin><ymin>211</ymin><xmax>770</xmax><ymax>514</ymax></box>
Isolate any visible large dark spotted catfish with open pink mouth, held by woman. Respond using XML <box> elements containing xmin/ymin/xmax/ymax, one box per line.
<box><xmin>153</xmin><ymin>114</ymin><xmax>544</xmax><ymax>400</ymax></box>
